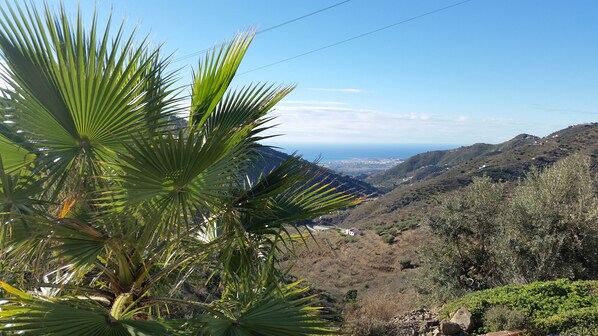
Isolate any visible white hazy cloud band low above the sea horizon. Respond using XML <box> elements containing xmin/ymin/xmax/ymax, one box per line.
<box><xmin>272</xmin><ymin>101</ymin><xmax>529</xmax><ymax>144</ymax></box>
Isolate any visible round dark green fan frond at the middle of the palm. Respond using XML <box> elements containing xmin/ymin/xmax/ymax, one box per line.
<box><xmin>117</xmin><ymin>131</ymin><xmax>247</xmax><ymax>228</ymax></box>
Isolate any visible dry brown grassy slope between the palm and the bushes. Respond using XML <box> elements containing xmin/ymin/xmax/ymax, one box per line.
<box><xmin>289</xmin><ymin>230</ymin><xmax>425</xmax><ymax>318</ymax></box>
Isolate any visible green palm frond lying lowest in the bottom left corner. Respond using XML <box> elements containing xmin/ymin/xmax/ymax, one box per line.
<box><xmin>0</xmin><ymin>281</ymin><xmax>170</xmax><ymax>336</ymax></box>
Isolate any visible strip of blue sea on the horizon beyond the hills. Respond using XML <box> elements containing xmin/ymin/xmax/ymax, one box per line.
<box><xmin>278</xmin><ymin>143</ymin><xmax>462</xmax><ymax>163</ymax></box>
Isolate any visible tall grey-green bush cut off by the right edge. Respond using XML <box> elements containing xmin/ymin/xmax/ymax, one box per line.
<box><xmin>505</xmin><ymin>155</ymin><xmax>598</xmax><ymax>282</ymax></box>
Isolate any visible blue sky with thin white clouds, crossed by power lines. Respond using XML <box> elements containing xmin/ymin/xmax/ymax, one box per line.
<box><xmin>36</xmin><ymin>0</ymin><xmax>598</xmax><ymax>144</ymax></box>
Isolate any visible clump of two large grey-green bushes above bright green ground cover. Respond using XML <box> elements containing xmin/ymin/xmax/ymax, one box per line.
<box><xmin>424</xmin><ymin>156</ymin><xmax>598</xmax><ymax>298</ymax></box>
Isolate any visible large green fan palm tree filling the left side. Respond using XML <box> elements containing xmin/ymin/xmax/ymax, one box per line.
<box><xmin>0</xmin><ymin>4</ymin><xmax>358</xmax><ymax>335</ymax></box>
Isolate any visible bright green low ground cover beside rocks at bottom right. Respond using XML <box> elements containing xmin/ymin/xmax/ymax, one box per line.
<box><xmin>440</xmin><ymin>280</ymin><xmax>598</xmax><ymax>335</ymax></box>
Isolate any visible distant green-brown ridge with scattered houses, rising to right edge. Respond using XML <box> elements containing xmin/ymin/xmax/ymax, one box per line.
<box><xmin>337</xmin><ymin>123</ymin><xmax>598</xmax><ymax>227</ymax></box>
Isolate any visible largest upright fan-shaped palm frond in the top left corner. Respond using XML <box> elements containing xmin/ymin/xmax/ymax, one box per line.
<box><xmin>0</xmin><ymin>4</ymin><xmax>177</xmax><ymax>181</ymax></box>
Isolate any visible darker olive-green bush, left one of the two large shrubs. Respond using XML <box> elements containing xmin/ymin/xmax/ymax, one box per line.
<box><xmin>427</xmin><ymin>177</ymin><xmax>504</xmax><ymax>290</ymax></box>
